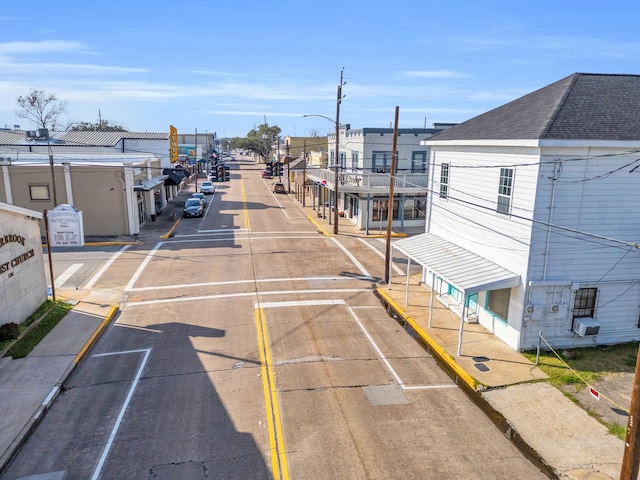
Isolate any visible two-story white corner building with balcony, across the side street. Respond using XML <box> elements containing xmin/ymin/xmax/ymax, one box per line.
<box><xmin>307</xmin><ymin>125</ymin><xmax>448</xmax><ymax>231</ymax></box>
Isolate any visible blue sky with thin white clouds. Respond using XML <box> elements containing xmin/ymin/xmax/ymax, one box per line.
<box><xmin>0</xmin><ymin>0</ymin><xmax>640</xmax><ymax>137</ymax></box>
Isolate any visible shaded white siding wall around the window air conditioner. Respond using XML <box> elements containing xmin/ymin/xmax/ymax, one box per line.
<box><xmin>523</xmin><ymin>149</ymin><xmax>640</xmax><ymax>347</ymax></box>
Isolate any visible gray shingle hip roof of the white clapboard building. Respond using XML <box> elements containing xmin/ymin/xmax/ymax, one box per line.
<box><xmin>429</xmin><ymin>73</ymin><xmax>640</xmax><ymax>142</ymax></box>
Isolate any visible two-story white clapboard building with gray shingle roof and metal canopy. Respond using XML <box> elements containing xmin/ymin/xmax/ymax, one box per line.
<box><xmin>393</xmin><ymin>73</ymin><xmax>640</xmax><ymax>350</ymax></box>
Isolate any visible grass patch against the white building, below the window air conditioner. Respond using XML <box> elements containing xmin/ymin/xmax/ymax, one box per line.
<box><xmin>524</xmin><ymin>342</ymin><xmax>638</xmax><ymax>387</ymax></box>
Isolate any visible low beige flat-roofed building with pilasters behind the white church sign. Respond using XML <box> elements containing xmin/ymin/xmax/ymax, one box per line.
<box><xmin>0</xmin><ymin>154</ymin><xmax>168</xmax><ymax>236</ymax></box>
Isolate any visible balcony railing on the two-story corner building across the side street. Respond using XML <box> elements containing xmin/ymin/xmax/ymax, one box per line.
<box><xmin>307</xmin><ymin>167</ymin><xmax>428</xmax><ymax>193</ymax></box>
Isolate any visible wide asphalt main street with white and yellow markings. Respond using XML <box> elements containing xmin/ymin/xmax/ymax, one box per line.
<box><xmin>3</xmin><ymin>156</ymin><xmax>546</xmax><ymax>479</ymax></box>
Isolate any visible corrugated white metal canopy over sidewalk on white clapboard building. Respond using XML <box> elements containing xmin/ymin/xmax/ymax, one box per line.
<box><xmin>392</xmin><ymin>233</ymin><xmax>520</xmax><ymax>295</ymax></box>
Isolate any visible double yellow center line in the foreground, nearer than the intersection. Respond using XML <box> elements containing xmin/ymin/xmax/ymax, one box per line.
<box><xmin>256</xmin><ymin>308</ymin><xmax>289</xmax><ymax>480</ymax></box>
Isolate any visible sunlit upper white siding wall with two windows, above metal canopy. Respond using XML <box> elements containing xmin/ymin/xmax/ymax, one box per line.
<box><xmin>427</xmin><ymin>147</ymin><xmax>537</xmax><ymax>274</ymax></box>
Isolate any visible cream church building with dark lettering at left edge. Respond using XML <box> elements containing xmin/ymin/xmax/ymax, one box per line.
<box><xmin>0</xmin><ymin>202</ymin><xmax>47</xmax><ymax>325</ymax></box>
